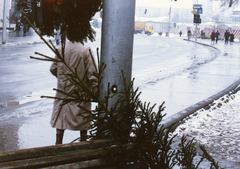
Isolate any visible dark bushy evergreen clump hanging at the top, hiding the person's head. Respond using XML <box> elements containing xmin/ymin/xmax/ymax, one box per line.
<box><xmin>17</xmin><ymin>0</ymin><xmax>102</xmax><ymax>43</ymax></box>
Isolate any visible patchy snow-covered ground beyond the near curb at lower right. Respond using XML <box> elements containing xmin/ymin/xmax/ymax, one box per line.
<box><xmin>175</xmin><ymin>92</ymin><xmax>240</xmax><ymax>162</ymax></box>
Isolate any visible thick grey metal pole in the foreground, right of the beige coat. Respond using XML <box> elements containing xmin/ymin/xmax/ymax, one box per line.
<box><xmin>99</xmin><ymin>0</ymin><xmax>135</xmax><ymax>107</ymax></box>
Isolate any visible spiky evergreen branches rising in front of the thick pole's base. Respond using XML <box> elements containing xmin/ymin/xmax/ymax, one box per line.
<box><xmin>27</xmin><ymin>19</ymin><xmax>223</xmax><ymax>169</ymax></box>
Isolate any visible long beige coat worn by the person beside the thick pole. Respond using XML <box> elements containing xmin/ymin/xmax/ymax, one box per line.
<box><xmin>50</xmin><ymin>42</ymin><xmax>94</xmax><ymax>130</ymax></box>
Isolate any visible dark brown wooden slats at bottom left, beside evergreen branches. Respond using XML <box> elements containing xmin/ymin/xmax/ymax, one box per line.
<box><xmin>0</xmin><ymin>140</ymin><xmax>124</xmax><ymax>169</ymax></box>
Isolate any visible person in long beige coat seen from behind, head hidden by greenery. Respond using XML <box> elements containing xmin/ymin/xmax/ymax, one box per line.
<box><xmin>50</xmin><ymin>32</ymin><xmax>95</xmax><ymax>144</ymax></box>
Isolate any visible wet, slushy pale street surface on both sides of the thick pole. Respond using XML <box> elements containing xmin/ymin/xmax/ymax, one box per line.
<box><xmin>0</xmin><ymin>31</ymin><xmax>240</xmax><ymax>151</ymax></box>
